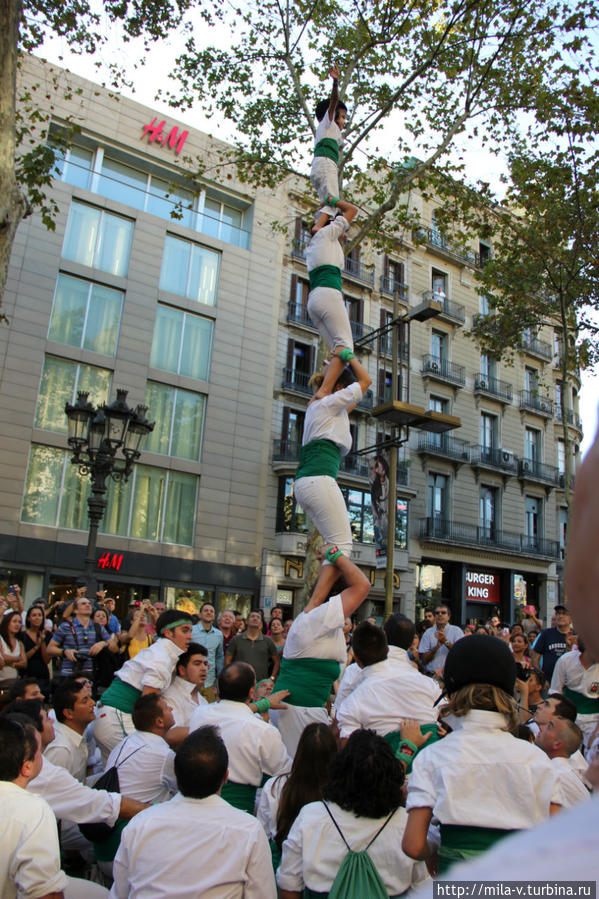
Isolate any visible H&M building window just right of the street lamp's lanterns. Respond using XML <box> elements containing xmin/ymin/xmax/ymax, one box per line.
<box><xmin>145</xmin><ymin>381</ymin><xmax>206</xmax><ymax>462</ymax></box>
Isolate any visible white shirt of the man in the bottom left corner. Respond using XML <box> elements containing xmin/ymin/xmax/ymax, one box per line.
<box><xmin>0</xmin><ymin>781</ymin><xmax>67</xmax><ymax>899</ymax></box>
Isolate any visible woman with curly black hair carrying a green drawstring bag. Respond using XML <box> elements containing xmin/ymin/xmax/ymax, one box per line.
<box><xmin>277</xmin><ymin>730</ymin><xmax>428</xmax><ymax>899</ymax></box>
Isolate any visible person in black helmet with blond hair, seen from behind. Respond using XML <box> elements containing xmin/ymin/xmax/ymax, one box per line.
<box><xmin>402</xmin><ymin>634</ymin><xmax>560</xmax><ymax>874</ymax></box>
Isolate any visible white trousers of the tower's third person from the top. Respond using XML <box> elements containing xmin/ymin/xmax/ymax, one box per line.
<box><xmin>293</xmin><ymin>475</ymin><xmax>353</xmax><ymax>565</ymax></box>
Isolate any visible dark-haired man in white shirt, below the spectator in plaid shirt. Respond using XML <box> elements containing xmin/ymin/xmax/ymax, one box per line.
<box><xmin>44</xmin><ymin>679</ymin><xmax>96</xmax><ymax>783</ymax></box>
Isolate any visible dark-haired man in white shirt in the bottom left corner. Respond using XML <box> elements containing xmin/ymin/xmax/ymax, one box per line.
<box><xmin>0</xmin><ymin>717</ymin><xmax>108</xmax><ymax>899</ymax></box>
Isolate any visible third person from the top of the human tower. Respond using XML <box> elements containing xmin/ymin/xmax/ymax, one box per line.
<box><xmin>294</xmin><ymin>357</ymin><xmax>371</xmax><ymax>596</ymax></box>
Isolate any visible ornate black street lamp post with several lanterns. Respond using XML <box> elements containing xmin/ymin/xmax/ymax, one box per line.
<box><xmin>65</xmin><ymin>389</ymin><xmax>154</xmax><ymax>598</ymax></box>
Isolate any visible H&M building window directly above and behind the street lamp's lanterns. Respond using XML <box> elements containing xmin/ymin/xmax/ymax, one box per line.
<box><xmin>35</xmin><ymin>356</ymin><xmax>112</xmax><ymax>434</ymax></box>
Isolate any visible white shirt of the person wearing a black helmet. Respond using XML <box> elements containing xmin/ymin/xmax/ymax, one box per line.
<box><xmin>406</xmin><ymin>709</ymin><xmax>560</xmax><ymax>830</ymax></box>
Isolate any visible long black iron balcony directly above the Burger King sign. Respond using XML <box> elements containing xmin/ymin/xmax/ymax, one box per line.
<box><xmin>418</xmin><ymin>517</ymin><xmax>559</xmax><ymax>559</ymax></box>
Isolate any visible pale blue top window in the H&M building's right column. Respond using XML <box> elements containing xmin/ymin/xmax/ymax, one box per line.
<box><xmin>160</xmin><ymin>234</ymin><xmax>220</xmax><ymax>306</ymax></box>
